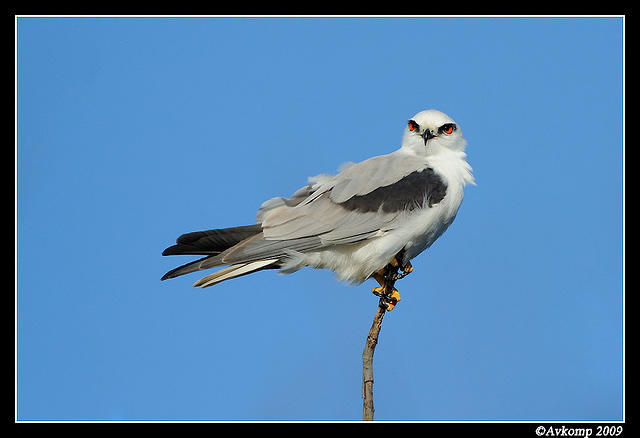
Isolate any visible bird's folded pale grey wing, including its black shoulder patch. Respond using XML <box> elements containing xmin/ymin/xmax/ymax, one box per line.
<box><xmin>221</xmin><ymin>154</ymin><xmax>444</xmax><ymax>264</ymax></box>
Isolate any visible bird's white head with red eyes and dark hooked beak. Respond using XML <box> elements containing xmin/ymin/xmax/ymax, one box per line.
<box><xmin>402</xmin><ymin>109</ymin><xmax>467</xmax><ymax>156</ymax></box>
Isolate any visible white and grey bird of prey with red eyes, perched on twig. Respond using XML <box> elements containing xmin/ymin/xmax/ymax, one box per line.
<box><xmin>161</xmin><ymin>109</ymin><xmax>475</xmax><ymax>310</ymax></box>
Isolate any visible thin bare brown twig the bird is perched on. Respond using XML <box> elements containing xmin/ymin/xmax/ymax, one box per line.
<box><xmin>362</xmin><ymin>265</ymin><xmax>404</xmax><ymax>421</ymax></box>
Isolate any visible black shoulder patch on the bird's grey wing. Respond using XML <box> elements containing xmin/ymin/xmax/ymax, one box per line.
<box><xmin>339</xmin><ymin>167</ymin><xmax>447</xmax><ymax>213</ymax></box>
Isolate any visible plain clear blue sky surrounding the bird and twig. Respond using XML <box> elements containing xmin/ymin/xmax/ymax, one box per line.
<box><xmin>16</xmin><ymin>17</ymin><xmax>624</xmax><ymax>421</ymax></box>
